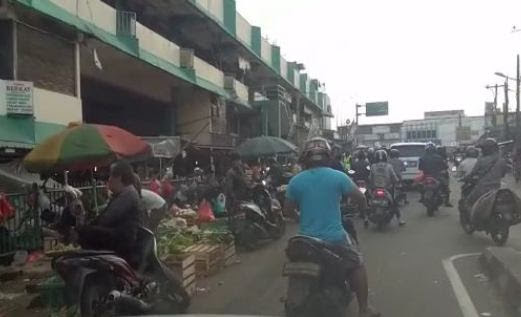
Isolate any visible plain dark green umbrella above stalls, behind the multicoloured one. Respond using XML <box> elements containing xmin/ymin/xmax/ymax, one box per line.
<box><xmin>237</xmin><ymin>136</ymin><xmax>297</xmax><ymax>157</ymax></box>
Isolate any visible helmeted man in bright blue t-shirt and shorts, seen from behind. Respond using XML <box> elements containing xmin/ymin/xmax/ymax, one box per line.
<box><xmin>284</xmin><ymin>138</ymin><xmax>380</xmax><ymax>317</ymax></box>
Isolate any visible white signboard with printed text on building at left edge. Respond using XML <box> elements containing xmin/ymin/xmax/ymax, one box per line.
<box><xmin>0</xmin><ymin>80</ymin><xmax>34</xmax><ymax>115</ymax></box>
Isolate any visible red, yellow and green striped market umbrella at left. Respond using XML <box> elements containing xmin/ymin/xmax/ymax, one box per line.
<box><xmin>24</xmin><ymin>124</ymin><xmax>151</xmax><ymax>173</ymax></box>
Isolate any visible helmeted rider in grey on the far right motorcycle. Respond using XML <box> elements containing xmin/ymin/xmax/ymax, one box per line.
<box><xmin>464</xmin><ymin>138</ymin><xmax>508</xmax><ymax>207</ymax></box>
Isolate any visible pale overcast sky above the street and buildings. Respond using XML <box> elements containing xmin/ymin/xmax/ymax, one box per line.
<box><xmin>237</xmin><ymin>0</ymin><xmax>521</xmax><ymax>123</ymax></box>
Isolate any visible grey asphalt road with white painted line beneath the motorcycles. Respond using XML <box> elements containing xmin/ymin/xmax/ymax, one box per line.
<box><xmin>192</xmin><ymin>178</ymin><xmax>521</xmax><ymax>317</ymax></box>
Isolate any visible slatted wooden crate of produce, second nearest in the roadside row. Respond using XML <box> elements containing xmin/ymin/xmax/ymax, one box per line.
<box><xmin>184</xmin><ymin>244</ymin><xmax>223</xmax><ymax>277</ymax></box>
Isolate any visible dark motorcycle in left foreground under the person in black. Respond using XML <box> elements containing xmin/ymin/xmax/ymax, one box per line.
<box><xmin>52</xmin><ymin>227</ymin><xmax>190</xmax><ymax>317</ymax></box>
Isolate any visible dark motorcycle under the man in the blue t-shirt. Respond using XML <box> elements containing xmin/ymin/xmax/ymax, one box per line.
<box><xmin>283</xmin><ymin>236</ymin><xmax>353</xmax><ymax>317</ymax></box>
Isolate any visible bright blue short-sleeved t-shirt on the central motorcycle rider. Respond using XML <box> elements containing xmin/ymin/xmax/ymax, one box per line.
<box><xmin>287</xmin><ymin>167</ymin><xmax>356</xmax><ymax>242</ymax></box>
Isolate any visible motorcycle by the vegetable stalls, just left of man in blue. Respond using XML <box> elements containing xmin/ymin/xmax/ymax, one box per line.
<box><xmin>229</xmin><ymin>184</ymin><xmax>286</xmax><ymax>250</ymax></box>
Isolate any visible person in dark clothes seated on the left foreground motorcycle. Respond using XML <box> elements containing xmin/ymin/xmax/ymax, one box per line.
<box><xmin>77</xmin><ymin>161</ymin><xmax>143</xmax><ymax>265</ymax></box>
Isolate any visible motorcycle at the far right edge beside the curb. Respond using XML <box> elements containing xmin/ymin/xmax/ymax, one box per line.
<box><xmin>459</xmin><ymin>183</ymin><xmax>521</xmax><ymax>246</ymax></box>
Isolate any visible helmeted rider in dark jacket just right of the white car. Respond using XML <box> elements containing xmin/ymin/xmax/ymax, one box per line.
<box><xmin>418</xmin><ymin>142</ymin><xmax>452</xmax><ymax>207</ymax></box>
